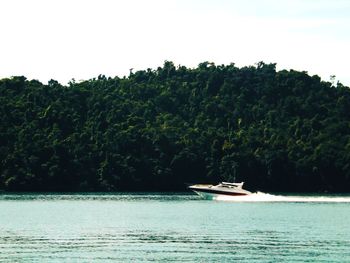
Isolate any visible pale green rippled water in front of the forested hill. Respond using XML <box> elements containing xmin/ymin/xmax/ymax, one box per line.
<box><xmin>0</xmin><ymin>194</ymin><xmax>350</xmax><ymax>263</ymax></box>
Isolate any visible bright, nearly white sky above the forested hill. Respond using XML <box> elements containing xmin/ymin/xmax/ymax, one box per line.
<box><xmin>0</xmin><ymin>0</ymin><xmax>350</xmax><ymax>86</ymax></box>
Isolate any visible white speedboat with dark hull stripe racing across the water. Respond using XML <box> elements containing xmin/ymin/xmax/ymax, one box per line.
<box><xmin>188</xmin><ymin>182</ymin><xmax>252</xmax><ymax>199</ymax></box>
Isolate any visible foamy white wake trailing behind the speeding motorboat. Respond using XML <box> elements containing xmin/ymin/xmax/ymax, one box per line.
<box><xmin>214</xmin><ymin>192</ymin><xmax>350</xmax><ymax>203</ymax></box>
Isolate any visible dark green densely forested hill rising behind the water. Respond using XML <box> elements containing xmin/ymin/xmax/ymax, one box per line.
<box><xmin>0</xmin><ymin>61</ymin><xmax>350</xmax><ymax>192</ymax></box>
